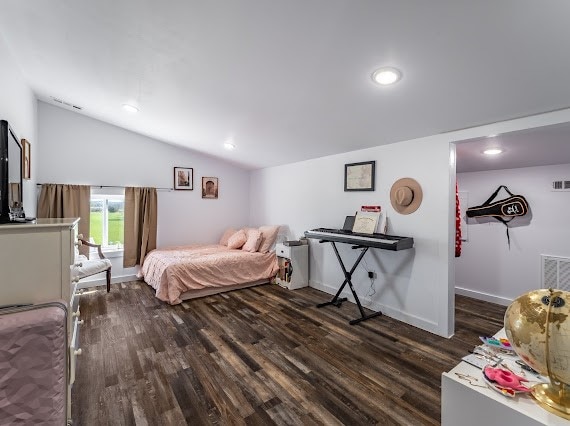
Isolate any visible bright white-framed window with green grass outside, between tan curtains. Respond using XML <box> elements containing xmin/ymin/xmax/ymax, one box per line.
<box><xmin>89</xmin><ymin>192</ymin><xmax>125</xmax><ymax>250</ymax></box>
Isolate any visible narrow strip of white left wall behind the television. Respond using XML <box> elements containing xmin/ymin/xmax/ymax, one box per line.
<box><xmin>0</xmin><ymin>35</ymin><xmax>39</xmax><ymax>216</ymax></box>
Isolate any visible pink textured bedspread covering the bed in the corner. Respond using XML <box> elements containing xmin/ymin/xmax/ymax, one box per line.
<box><xmin>139</xmin><ymin>244</ymin><xmax>278</xmax><ymax>305</ymax></box>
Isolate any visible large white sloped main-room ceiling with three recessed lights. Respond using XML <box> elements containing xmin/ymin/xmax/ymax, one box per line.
<box><xmin>0</xmin><ymin>0</ymin><xmax>570</xmax><ymax>168</ymax></box>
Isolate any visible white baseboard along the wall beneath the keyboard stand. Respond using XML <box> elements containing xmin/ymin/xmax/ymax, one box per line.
<box><xmin>309</xmin><ymin>280</ymin><xmax>440</xmax><ymax>336</ymax></box>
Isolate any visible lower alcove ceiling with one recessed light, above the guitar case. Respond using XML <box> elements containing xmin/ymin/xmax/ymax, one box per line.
<box><xmin>456</xmin><ymin>123</ymin><xmax>570</xmax><ymax>173</ymax></box>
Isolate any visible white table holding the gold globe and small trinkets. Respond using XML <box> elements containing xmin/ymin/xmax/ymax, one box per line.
<box><xmin>441</xmin><ymin>330</ymin><xmax>570</xmax><ymax>426</ymax></box>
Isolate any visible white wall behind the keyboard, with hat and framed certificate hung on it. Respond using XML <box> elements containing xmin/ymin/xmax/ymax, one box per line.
<box><xmin>251</xmin><ymin>109</ymin><xmax>570</xmax><ymax>336</ymax></box>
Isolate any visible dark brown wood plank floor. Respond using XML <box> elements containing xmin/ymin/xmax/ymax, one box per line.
<box><xmin>72</xmin><ymin>282</ymin><xmax>505</xmax><ymax>426</ymax></box>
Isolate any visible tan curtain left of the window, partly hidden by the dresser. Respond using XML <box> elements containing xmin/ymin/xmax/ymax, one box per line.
<box><xmin>37</xmin><ymin>183</ymin><xmax>91</xmax><ymax>256</ymax></box>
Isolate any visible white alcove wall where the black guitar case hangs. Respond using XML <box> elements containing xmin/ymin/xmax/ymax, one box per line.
<box><xmin>455</xmin><ymin>163</ymin><xmax>570</xmax><ymax>305</ymax></box>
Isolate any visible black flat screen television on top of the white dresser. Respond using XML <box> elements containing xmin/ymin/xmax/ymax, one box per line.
<box><xmin>0</xmin><ymin>120</ymin><xmax>23</xmax><ymax>223</ymax></box>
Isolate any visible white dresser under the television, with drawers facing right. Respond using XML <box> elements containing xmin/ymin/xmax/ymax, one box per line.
<box><xmin>0</xmin><ymin>218</ymin><xmax>82</xmax><ymax>424</ymax></box>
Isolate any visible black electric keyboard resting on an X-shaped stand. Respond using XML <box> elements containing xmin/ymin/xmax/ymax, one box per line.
<box><xmin>305</xmin><ymin>228</ymin><xmax>414</xmax><ymax>250</ymax></box>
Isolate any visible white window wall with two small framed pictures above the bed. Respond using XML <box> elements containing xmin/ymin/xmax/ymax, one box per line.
<box><xmin>38</xmin><ymin>102</ymin><xmax>249</xmax><ymax>281</ymax></box>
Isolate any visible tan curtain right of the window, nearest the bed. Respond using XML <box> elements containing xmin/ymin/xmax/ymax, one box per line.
<box><xmin>123</xmin><ymin>187</ymin><xmax>157</xmax><ymax>268</ymax></box>
